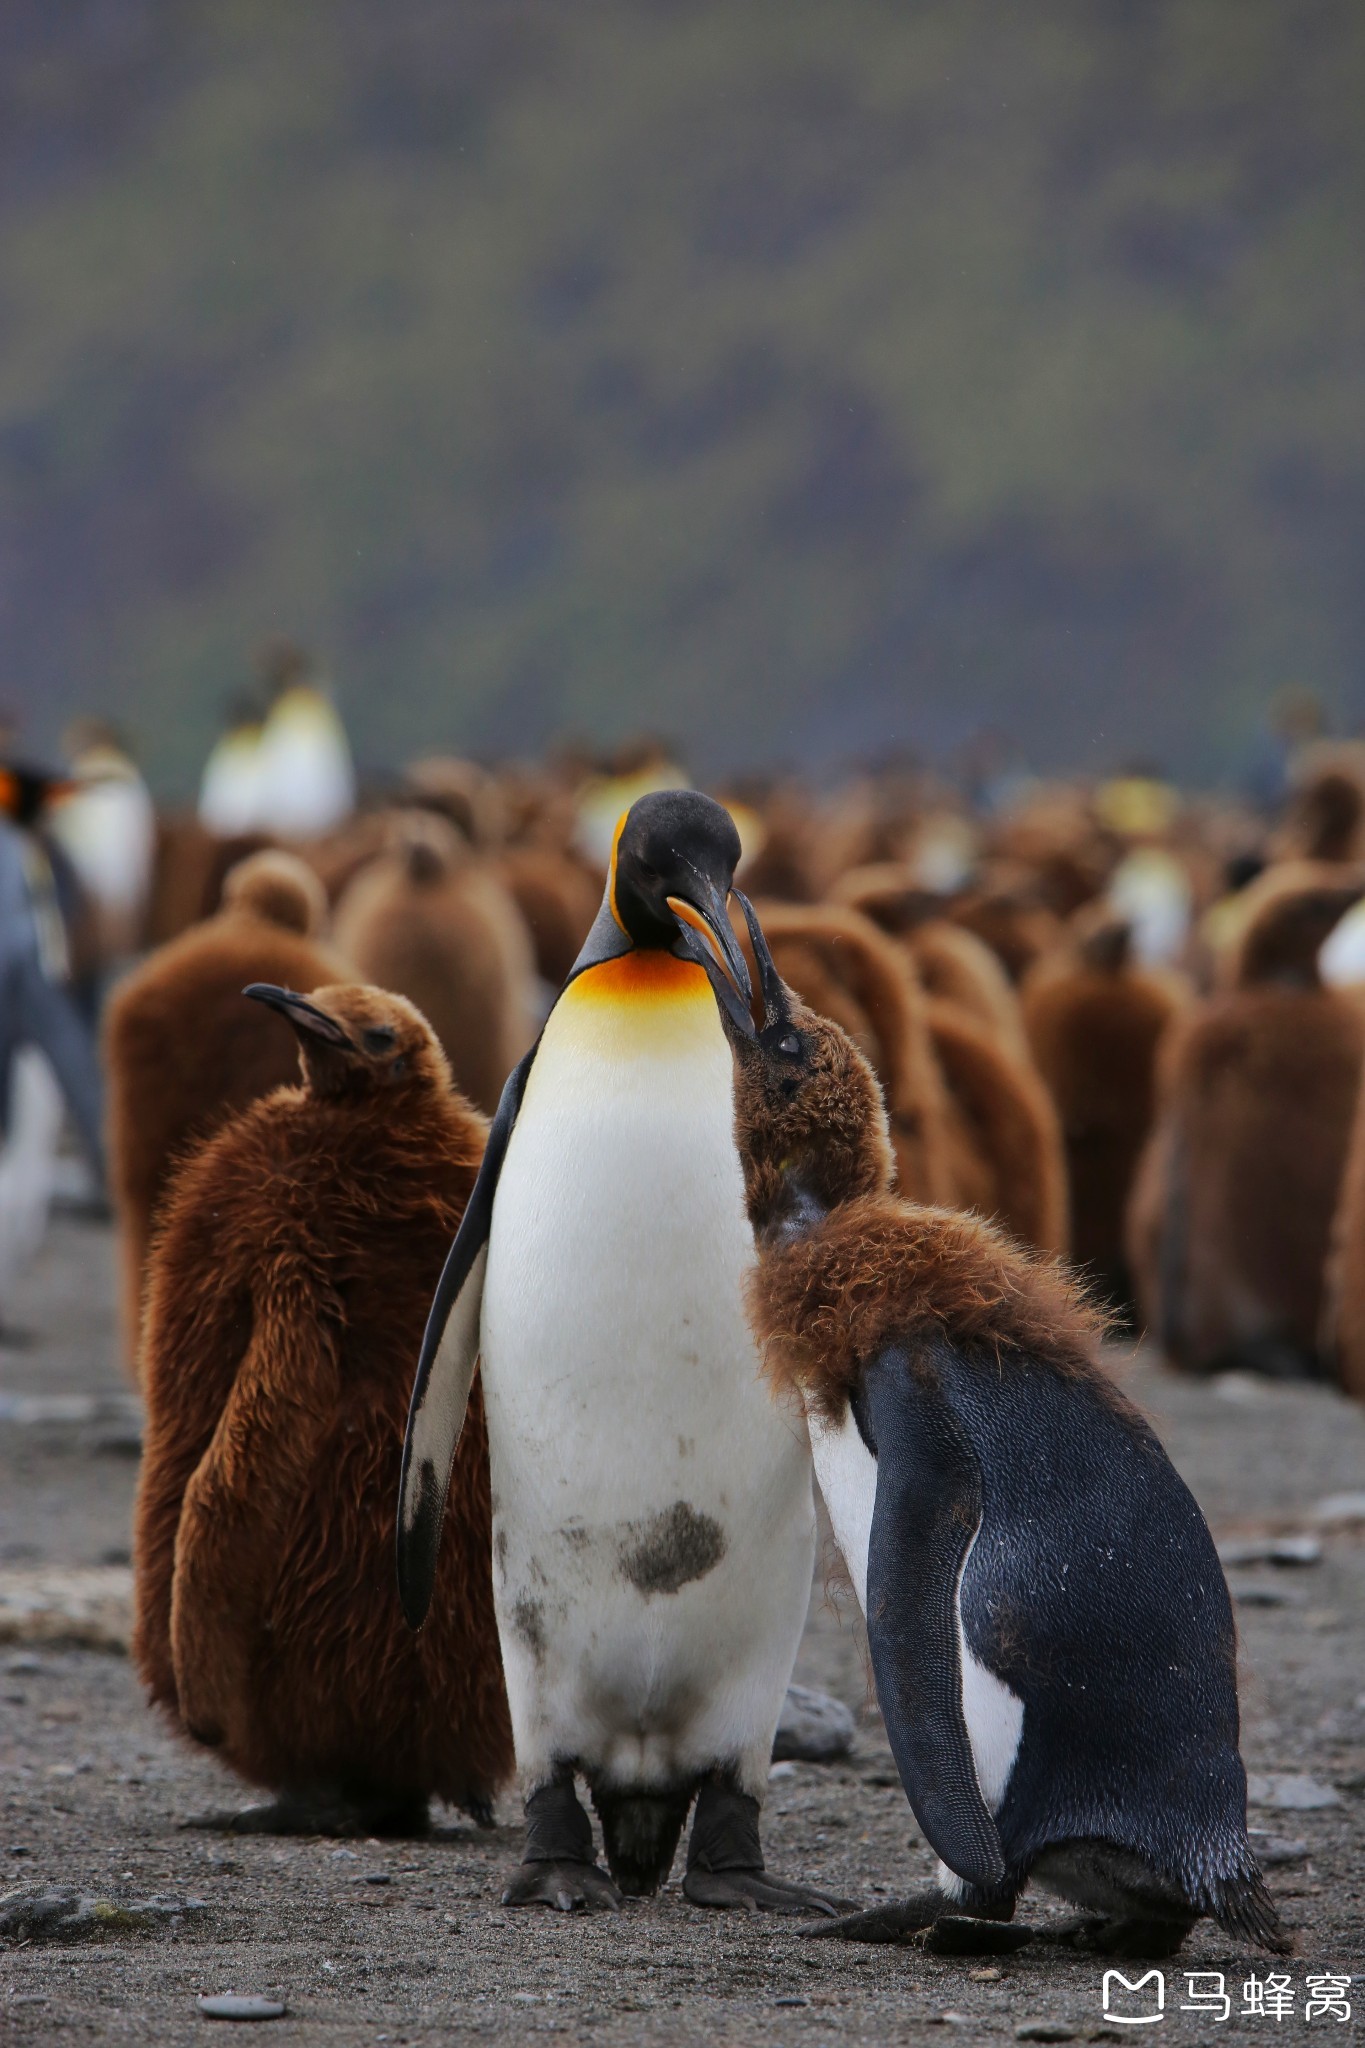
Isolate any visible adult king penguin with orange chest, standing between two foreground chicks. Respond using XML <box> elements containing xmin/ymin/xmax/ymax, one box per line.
<box><xmin>399</xmin><ymin>791</ymin><xmax>831</xmax><ymax>1913</ymax></box>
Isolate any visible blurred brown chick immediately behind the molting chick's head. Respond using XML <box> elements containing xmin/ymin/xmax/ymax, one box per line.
<box><xmin>749</xmin><ymin>903</ymin><xmax>958</xmax><ymax>1202</ymax></box>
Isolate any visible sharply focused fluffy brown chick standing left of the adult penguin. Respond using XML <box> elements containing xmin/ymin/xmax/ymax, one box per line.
<box><xmin>133</xmin><ymin>987</ymin><xmax>512</xmax><ymax>1833</ymax></box>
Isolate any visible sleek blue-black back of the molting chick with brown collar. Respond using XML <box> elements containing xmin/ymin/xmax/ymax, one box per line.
<box><xmin>853</xmin><ymin>1335</ymin><xmax>1259</xmax><ymax>1935</ymax></box>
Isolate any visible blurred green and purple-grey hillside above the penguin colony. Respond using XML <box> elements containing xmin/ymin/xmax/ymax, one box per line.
<box><xmin>0</xmin><ymin>0</ymin><xmax>1365</xmax><ymax>791</ymax></box>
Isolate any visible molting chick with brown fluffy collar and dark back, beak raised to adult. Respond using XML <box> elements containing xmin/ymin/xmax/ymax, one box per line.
<box><xmin>683</xmin><ymin>920</ymin><xmax>1285</xmax><ymax>1954</ymax></box>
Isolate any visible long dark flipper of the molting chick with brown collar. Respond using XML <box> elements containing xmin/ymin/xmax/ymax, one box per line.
<box><xmin>853</xmin><ymin>1348</ymin><xmax>1005</xmax><ymax>1890</ymax></box>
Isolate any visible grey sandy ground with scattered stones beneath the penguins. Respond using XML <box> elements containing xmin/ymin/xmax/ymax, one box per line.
<box><xmin>0</xmin><ymin>1221</ymin><xmax>1365</xmax><ymax>2048</ymax></box>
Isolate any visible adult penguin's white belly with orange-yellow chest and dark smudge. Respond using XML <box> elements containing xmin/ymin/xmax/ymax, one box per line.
<box><xmin>481</xmin><ymin>954</ymin><xmax>814</xmax><ymax>1794</ymax></box>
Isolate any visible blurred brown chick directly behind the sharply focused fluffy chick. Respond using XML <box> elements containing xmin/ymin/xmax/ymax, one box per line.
<box><xmin>104</xmin><ymin>852</ymin><xmax>338</xmax><ymax>1370</ymax></box>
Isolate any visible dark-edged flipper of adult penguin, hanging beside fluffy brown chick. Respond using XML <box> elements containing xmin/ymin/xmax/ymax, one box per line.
<box><xmin>399</xmin><ymin>1040</ymin><xmax>538</xmax><ymax>1628</ymax></box>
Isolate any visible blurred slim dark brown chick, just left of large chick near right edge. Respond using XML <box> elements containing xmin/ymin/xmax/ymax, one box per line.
<box><xmin>1023</xmin><ymin>911</ymin><xmax>1183</xmax><ymax>1309</ymax></box>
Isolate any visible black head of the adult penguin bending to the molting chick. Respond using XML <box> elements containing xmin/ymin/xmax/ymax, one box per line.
<box><xmin>608</xmin><ymin>788</ymin><xmax>749</xmax><ymax>997</ymax></box>
